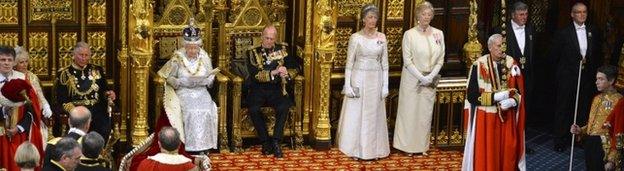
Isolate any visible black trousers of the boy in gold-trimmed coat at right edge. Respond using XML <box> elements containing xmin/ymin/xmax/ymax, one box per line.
<box><xmin>583</xmin><ymin>136</ymin><xmax>605</xmax><ymax>170</ymax></box>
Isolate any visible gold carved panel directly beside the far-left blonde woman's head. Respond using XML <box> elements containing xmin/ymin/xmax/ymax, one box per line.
<box><xmin>28</xmin><ymin>32</ymin><xmax>50</xmax><ymax>75</ymax></box>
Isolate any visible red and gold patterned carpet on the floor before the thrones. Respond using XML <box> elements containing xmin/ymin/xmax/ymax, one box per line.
<box><xmin>210</xmin><ymin>146</ymin><xmax>462</xmax><ymax>170</ymax></box>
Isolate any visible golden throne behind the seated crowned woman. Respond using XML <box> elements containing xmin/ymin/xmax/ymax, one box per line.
<box><xmin>119</xmin><ymin>0</ymin><xmax>229</xmax><ymax>170</ymax></box>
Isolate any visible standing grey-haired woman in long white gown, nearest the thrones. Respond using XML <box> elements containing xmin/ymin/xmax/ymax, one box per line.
<box><xmin>336</xmin><ymin>5</ymin><xmax>390</xmax><ymax>160</ymax></box>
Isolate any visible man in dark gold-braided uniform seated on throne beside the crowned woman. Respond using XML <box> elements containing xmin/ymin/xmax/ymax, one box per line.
<box><xmin>245</xmin><ymin>25</ymin><xmax>298</xmax><ymax>158</ymax></box>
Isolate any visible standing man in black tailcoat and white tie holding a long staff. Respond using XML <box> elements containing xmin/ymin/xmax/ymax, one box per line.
<box><xmin>550</xmin><ymin>3</ymin><xmax>604</xmax><ymax>152</ymax></box>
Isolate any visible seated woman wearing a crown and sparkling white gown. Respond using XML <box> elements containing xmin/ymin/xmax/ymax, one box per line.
<box><xmin>158</xmin><ymin>22</ymin><xmax>218</xmax><ymax>152</ymax></box>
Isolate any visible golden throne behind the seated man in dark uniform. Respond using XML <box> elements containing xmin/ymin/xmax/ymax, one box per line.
<box><xmin>219</xmin><ymin>0</ymin><xmax>304</xmax><ymax>151</ymax></box>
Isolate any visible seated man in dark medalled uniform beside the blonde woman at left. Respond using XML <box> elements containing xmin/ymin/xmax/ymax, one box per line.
<box><xmin>54</xmin><ymin>42</ymin><xmax>116</xmax><ymax>142</ymax></box>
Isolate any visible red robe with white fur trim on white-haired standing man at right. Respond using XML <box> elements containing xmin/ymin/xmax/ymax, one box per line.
<box><xmin>462</xmin><ymin>55</ymin><xmax>526</xmax><ymax>171</ymax></box>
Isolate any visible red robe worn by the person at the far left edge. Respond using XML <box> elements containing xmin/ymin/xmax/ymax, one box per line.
<box><xmin>0</xmin><ymin>80</ymin><xmax>44</xmax><ymax>170</ymax></box>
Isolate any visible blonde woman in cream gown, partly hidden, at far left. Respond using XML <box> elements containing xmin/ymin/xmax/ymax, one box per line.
<box><xmin>13</xmin><ymin>46</ymin><xmax>52</xmax><ymax>146</ymax></box>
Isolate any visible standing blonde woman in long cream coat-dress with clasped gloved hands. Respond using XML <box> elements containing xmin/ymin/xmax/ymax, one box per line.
<box><xmin>392</xmin><ymin>1</ymin><xmax>444</xmax><ymax>155</ymax></box>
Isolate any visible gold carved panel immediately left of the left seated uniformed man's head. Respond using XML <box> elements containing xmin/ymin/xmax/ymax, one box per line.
<box><xmin>58</xmin><ymin>32</ymin><xmax>78</xmax><ymax>68</ymax></box>
